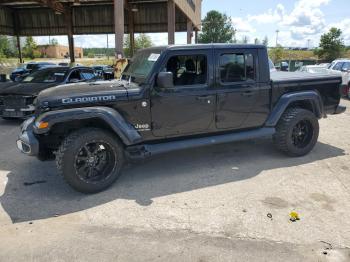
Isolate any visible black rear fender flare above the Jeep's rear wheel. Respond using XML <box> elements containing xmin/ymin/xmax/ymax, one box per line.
<box><xmin>265</xmin><ymin>90</ymin><xmax>324</xmax><ymax>127</ymax></box>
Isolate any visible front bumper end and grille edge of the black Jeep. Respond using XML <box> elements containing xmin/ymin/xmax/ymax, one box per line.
<box><xmin>17</xmin><ymin>117</ymin><xmax>39</xmax><ymax>156</ymax></box>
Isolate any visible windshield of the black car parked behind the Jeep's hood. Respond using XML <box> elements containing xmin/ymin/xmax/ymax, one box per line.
<box><xmin>22</xmin><ymin>68</ymin><xmax>68</xmax><ymax>83</ymax></box>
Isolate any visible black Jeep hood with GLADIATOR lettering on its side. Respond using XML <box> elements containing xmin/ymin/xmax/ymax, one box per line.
<box><xmin>37</xmin><ymin>80</ymin><xmax>141</xmax><ymax>108</ymax></box>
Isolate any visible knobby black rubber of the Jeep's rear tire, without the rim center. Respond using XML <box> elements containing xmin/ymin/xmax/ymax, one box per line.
<box><xmin>273</xmin><ymin>108</ymin><xmax>319</xmax><ymax>157</ymax></box>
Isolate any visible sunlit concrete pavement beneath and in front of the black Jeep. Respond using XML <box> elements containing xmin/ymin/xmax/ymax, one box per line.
<box><xmin>0</xmin><ymin>100</ymin><xmax>350</xmax><ymax>261</ymax></box>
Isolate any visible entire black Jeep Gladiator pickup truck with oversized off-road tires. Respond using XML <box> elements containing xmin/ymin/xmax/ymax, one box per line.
<box><xmin>17</xmin><ymin>44</ymin><xmax>345</xmax><ymax>193</ymax></box>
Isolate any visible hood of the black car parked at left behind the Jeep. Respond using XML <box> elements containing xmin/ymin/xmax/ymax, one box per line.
<box><xmin>0</xmin><ymin>82</ymin><xmax>60</xmax><ymax>96</ymax></box>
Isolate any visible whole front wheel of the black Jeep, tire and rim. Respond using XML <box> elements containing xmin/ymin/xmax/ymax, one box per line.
<box><xmin>56</xmin><ymin>128</ymin><xmax>124</xmax><ymax>193</ymax></box>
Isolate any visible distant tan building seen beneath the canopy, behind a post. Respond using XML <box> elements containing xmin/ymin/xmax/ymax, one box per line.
<box><xmin>38</xmin><ymin>45</ymin><xmax>83</xmax><ymax>58</ymax></box>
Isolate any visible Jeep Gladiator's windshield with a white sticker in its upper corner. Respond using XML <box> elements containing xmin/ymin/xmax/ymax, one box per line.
<box><xmin>122</xmin><ymin>49</ymin><xmax>161</xmax><ymax>82</ymax></box>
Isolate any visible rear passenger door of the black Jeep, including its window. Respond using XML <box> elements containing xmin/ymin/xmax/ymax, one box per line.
<box><xmin>215</xmin><ymin>49</ymin><xmax>259</xmax><ymax>130</ymax></box>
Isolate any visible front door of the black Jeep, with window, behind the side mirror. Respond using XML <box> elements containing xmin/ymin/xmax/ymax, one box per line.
<box><xmin>151</xmin><ymin>50</ymin><xmax>216</xmax><ymax>137</ymax></box>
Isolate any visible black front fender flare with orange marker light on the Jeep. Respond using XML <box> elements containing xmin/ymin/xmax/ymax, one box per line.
<box><xmin>34</xmin><ymin>106</ymin><xmax>142</xmax><ymax>145</ymax></box>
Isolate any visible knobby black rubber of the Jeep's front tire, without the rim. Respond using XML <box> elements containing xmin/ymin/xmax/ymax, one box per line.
<box><xmin>56</xmin><ymin>128</ymin><xmax>124</xmax><ymax>194</ymax></box>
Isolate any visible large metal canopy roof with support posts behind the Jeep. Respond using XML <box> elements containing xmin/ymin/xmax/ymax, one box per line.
<box><xmin>0</xmin><ymin>0</ymin><xmax>202</xmax><ymax>62</ymax></box>
